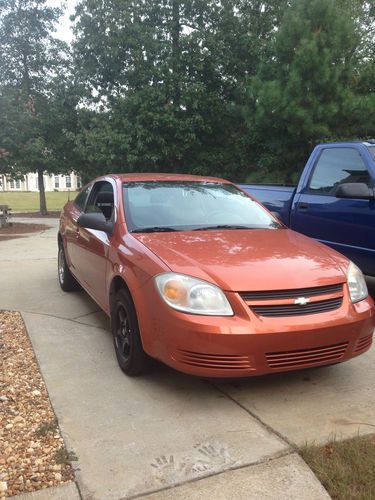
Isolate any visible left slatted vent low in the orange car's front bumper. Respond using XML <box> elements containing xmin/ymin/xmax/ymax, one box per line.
<box><xmin>172</xmin><ymin>349</ymin><xmax>255</xmax><ymax>370</ymax></box>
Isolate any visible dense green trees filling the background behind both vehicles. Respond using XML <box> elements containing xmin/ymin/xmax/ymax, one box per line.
<box><xmin>0</xmin><ymin>0</ymin><xmax>375</xmax><ymax>189</ymax></box>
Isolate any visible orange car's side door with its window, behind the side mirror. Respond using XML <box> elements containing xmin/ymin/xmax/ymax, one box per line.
<box><xmin>74</xmin><ymin>181</ymin><xmax>116</xmax><ymax>307</ymax></box>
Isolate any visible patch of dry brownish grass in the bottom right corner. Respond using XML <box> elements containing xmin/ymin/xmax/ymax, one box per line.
<box><xmin>300</xmin><ymin>435</ymin><xmax>375</xmax><ymax>500</ymax></box>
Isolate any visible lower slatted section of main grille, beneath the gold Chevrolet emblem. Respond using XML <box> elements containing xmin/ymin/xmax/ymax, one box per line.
<box><xmin>251</xmin><ymin>297</ymin><xmax>342</xmax><ymax>317</ymax></box>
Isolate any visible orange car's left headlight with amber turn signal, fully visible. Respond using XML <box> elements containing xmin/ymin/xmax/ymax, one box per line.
<box><xmin>154</xmin><ymin>273</ymin><xmax>233</xmax><ymax>316</ymax></box>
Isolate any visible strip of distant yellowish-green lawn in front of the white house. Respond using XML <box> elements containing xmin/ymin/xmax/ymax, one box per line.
<box><xmin>0</xmin><ymin>191</ymin><xmax>76</xmax><ymax>212</ymax></box>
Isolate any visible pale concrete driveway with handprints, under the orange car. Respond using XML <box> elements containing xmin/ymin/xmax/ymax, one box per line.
<box><xmin>0</xmin><ymin>220</ymin><xmax>375</xmax><ymax>500</ymax></box>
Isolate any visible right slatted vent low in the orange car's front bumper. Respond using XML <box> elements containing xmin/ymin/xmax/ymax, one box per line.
<box><xmin>266</xmin><ymin>342</ymin><xmax>349</xmax><ymax>369</ymax></box>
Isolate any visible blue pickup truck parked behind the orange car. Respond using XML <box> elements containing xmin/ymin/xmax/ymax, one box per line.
<box><xmin>240</xmin><ymin>141</ymin><xmax>375</xmax><ymax>276</ymax></box>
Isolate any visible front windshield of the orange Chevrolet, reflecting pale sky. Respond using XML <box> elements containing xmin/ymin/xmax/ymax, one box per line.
<box><xmin>124</xmin><ymin>181</ymin><xmax>281</xmax><ymax>232</ymax></box>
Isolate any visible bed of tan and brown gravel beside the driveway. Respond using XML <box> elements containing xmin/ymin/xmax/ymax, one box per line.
<box><xmin>0</xmin><ymin>311</ymin><xmax>76</xmax><ymax>498</ymax></box>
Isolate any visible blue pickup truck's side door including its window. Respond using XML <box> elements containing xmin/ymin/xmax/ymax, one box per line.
<box><xmin>291</xmin><ymin>146</ymin><xmax>375</xmax><ymax>274</ymax></box>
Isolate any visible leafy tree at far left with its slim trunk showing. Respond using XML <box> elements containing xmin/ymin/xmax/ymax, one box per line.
<box><xmin>0</xmin><ymin>0</ymin><xmax>77</xmax><ymax>214</ymax></box>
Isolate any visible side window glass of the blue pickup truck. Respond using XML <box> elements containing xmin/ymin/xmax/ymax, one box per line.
<box><xmin>309</xmin><ymin>148</ymin><xmax>371</xmax><ymax>196</ymax></box>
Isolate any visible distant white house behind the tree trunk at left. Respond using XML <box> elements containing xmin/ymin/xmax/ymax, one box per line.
<box><xmin>0</xmin><ymin>172</ymin><xmax>82</xmax><ymax>191</ymax></box>
